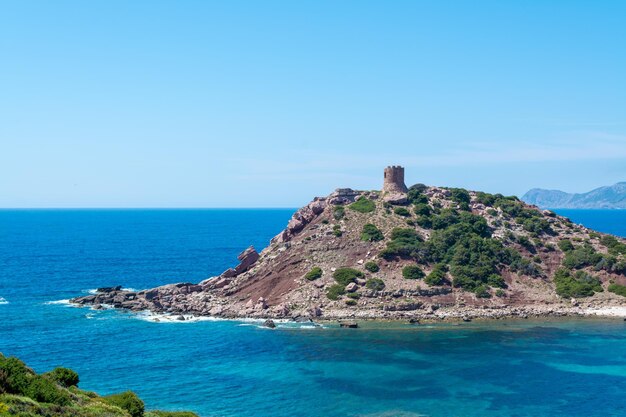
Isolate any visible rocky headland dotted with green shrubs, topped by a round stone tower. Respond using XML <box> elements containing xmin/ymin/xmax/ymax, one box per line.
<box><xmin>72</xmin><ymin>167</ymin><xmax>626</xmax><ymax>320</ymax></box>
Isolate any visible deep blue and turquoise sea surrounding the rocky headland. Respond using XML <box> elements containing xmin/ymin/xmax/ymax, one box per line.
<box><xmin>0</xmin><ymin>210</ymin><xmax>626</xmax><ymax>417</ymax></box>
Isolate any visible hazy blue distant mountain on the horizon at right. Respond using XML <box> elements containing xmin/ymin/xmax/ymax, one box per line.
<box><xmin>522</xmin><ymin>182</ymin><xmax>626</xmax><ymax>209</ymax></box>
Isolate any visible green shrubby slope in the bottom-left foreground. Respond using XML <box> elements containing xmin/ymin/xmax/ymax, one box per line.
<box><xmin>0</xmin><ymin>353</ymin><xmax>198</xmax><ymax>417</ymax></box>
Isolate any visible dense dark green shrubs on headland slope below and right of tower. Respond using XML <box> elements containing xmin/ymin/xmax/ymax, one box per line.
<box><xmin>370</xmin><ymin>184</ymin><xmax>626</xmax><ymax>297</ymax></box>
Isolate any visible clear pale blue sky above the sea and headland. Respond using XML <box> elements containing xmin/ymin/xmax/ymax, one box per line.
<box><xmin>0</xmin><ymin>0</ymin><xmax>626</xmax><ymax>207</ymax></box>
